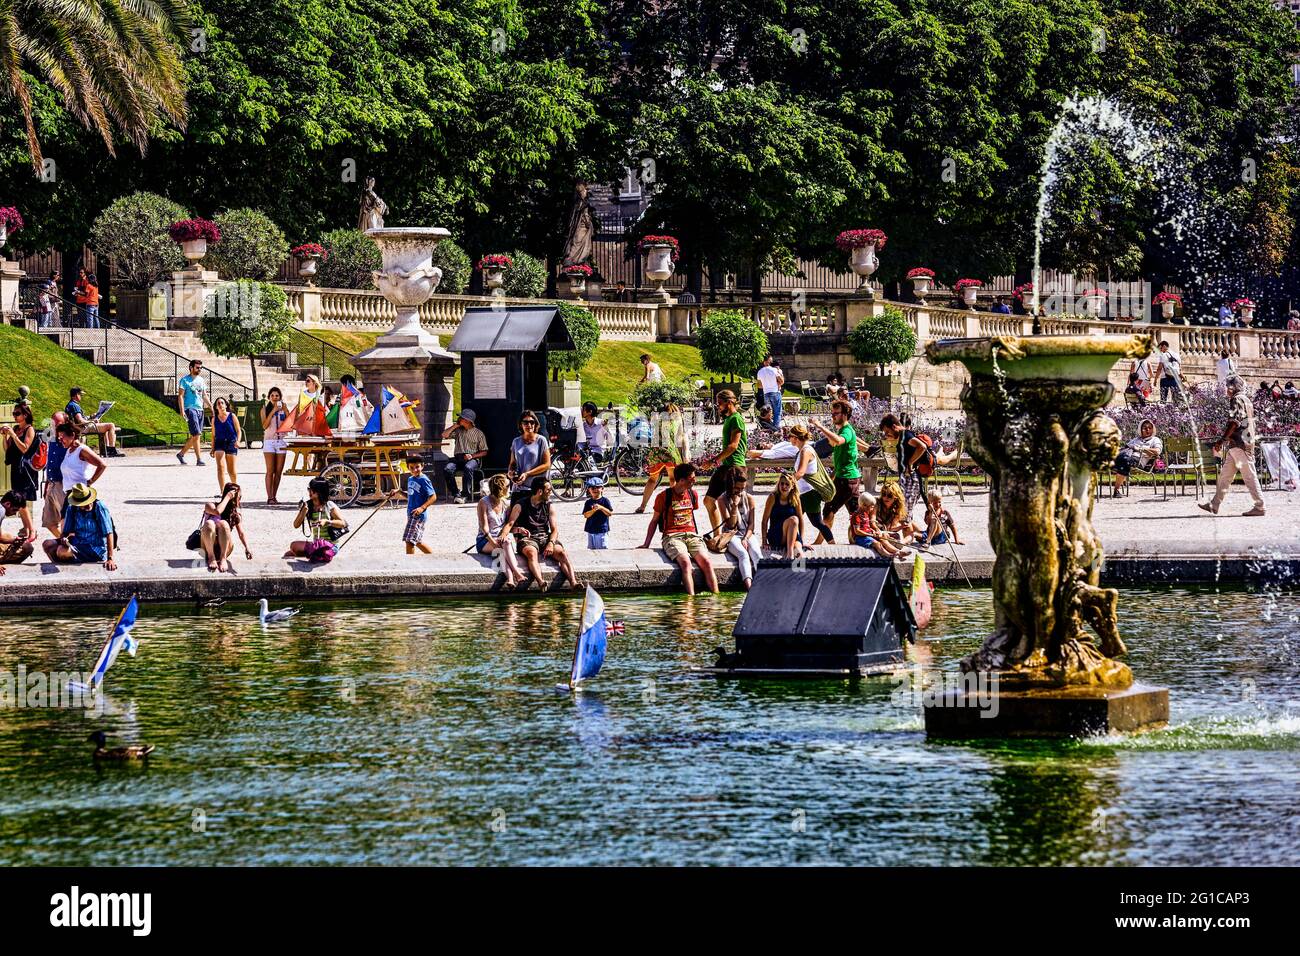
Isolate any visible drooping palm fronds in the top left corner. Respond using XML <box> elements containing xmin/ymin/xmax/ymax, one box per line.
<box><xmin>0</xmin><ymin>0</ymin><xmax>190</xmax><ymax>174</ymax></box>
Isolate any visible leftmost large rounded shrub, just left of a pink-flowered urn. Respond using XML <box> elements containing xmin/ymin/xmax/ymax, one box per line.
<box><xmin>90</xmin><ymin>193</ymin><xmax>189</xmax><ymax>289</ymax></box>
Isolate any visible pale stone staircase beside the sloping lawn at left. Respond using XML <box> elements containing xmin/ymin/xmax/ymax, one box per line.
<box><xmin>42</xmin><ymin>328</ymin><xmax>320</xmax><ymax>405</ymax></box>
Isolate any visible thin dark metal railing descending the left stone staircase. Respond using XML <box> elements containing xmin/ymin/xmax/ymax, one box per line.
<box><xmin>32</xmin><ymin>286</ymin><xmax>256</xmax><ymax>402</ymax></box>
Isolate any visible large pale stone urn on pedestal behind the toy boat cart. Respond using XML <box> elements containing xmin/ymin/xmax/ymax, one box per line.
<box><xmin>352</xmin><ymin>226</ymin><xmax>460</xmax><ymax>442</ymax></box>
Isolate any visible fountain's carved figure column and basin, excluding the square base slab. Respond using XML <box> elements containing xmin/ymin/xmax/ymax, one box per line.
<box><xmin>926</xmin><ymin>336</ymin><xmax>1151</xmax><ymax>688</ymax></box>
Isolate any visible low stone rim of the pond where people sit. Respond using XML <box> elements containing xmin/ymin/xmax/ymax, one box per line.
<box><xmin>0</xmin><ymin>553</ymin><xmax>1300</xmax><ymax>607</ymax></box>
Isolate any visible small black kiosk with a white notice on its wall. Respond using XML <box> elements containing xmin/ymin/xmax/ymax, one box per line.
<box><xmin>447</xmin><ymin>306</ymin><xmax>573</xmax><ymax>471</ymax></box>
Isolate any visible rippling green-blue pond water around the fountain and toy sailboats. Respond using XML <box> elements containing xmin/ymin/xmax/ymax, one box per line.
<box><xmin>0</xmin><ymin>588</ymin><xmax>1300</xmax><ymax>865</ymax></box>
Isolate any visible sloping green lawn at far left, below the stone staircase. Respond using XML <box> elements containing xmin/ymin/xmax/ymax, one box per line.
<box><xmin>0</xmin><ymin>325</ymin><xmax>186</xmax><ymax>434</ymax></box>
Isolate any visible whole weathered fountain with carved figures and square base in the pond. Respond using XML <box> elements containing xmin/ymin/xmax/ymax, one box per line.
<box><xmin>926</xmin><ymin>336</ymin><xmax>1169</xmax><ymax>737</ymax></box>
